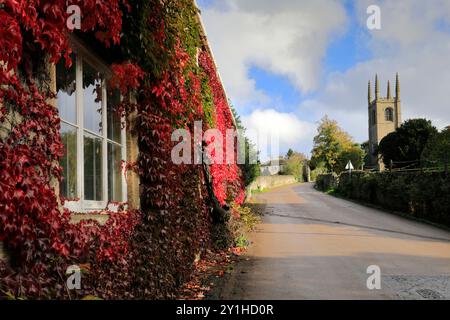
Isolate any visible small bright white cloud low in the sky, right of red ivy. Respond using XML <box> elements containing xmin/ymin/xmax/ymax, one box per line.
<box><xmin>242</xmin><ymin>109</ymin><xmax>315</xmax><ymax>161</ymax></box>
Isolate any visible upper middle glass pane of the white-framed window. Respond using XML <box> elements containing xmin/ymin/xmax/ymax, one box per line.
<box><xmin>83</xmin><ymin>61</ymin><xmax>102</xmax><ymax>134</ymax></box>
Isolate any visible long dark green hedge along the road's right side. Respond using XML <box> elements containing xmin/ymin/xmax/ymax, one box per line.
<box><xmin>316</xmin><ymin>171</ymin><xmax>450</xmax><ymax>227</ymax></box>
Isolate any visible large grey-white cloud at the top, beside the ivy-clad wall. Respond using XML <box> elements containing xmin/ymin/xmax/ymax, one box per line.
<box><xmin>202</xmin><ymin>0</ymin><xmax>346</xmax><ymax>105</ymax></box>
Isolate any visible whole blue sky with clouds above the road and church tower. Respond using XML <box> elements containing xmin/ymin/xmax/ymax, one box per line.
<box><xmin>197</xmin><ymin>0</ymin><xmax>450</xmax><ymax>158</ymax></box>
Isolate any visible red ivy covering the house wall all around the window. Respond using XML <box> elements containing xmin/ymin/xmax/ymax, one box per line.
<box><xmin>0</xmin><ymin>0</ymin><xmax>244</xmax><ymax>298</ymax></box>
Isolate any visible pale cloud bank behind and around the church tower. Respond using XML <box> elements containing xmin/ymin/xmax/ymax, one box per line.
<box><xmin>300</xmin><ymin>0</ymin><xmax>450</xmax><ymax>142</ymax></box>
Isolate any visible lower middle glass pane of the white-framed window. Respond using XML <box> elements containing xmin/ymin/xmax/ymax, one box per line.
<box><xmin>84</xmin><ymin>134</ymin><xmax>103</xmax><ymax>201</ymax></box>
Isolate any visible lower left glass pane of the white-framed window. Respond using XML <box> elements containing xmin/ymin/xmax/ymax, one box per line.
<box><xmin>60</xmin><ymin>123</ymin><xmax>78</xmax><ymax>199</ymax></box>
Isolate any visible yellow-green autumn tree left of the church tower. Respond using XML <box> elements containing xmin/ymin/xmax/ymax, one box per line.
<box><xmin>311</xmin><ymin>116</ymin><xmax>354</xmax><ymax>171</ymax></box>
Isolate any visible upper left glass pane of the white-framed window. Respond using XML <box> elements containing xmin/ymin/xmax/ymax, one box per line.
<box><xmin>56</xmin><ymin>56</ymin><xmax>77</xmax><ymax>124</ymax></box>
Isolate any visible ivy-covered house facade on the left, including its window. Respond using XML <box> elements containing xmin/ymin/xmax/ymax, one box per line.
<box><xmin>0</xmin><ymin>0</ymin><xmax>245</xmax><ymax>299</ymax></box>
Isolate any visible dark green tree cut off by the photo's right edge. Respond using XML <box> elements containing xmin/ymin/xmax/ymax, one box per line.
<box><xmin>422</xmin><ymin>127</ymin><xmax>450</xmax><ymax>171</ymax></box>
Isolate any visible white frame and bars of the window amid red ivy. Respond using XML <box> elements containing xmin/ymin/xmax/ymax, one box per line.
<box><xmin>61</xmin><ymin>38</ymin><xmax>128</xmax><ymax>213</ymax></box>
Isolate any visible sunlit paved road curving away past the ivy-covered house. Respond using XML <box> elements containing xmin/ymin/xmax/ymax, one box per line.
<box><xmin>221</xmin><ymin>184</ymin><xmax>450</xmax><ymax>299</ymax></box>
